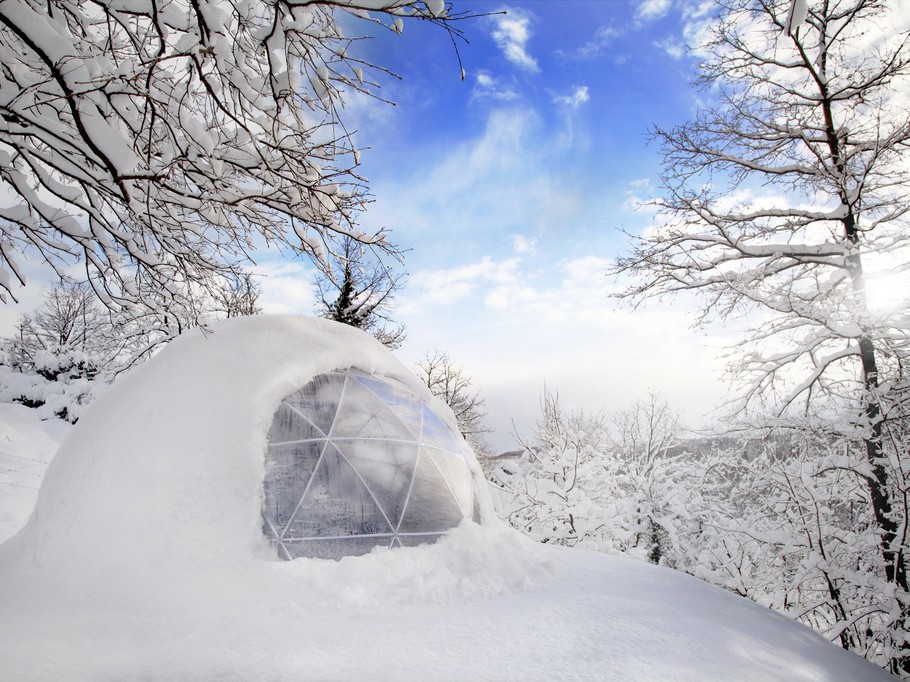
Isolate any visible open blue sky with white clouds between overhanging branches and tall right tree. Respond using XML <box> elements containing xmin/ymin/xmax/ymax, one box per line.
<box><xmin>314</xmin><ymin>0</ymin><xmax>740</xmax><ymax>449</ymax></box>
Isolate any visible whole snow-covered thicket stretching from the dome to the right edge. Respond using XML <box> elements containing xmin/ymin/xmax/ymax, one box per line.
<box><xmin>495</xmin><ymin>386</ymin><xmax>910</xmax><ymax>669</ymax></box>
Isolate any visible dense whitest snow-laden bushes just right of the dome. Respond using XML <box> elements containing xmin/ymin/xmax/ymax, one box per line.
<box><xmin>494</xmin><ymin>392</ymin><xmax>700</xmax><ymax>556</ymax></box>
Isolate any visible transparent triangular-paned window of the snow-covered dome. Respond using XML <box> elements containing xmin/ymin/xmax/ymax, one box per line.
<box><xmin>262</xmin><ymin>369</ymin><xmax>476</xmax><ymax>559</ymax></box>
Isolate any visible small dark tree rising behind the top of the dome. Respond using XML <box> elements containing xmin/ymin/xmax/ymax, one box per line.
<box><xmin>316</xmin><ymin>237</ymin><xmax>405</xmax><ymax>349</ymax></box>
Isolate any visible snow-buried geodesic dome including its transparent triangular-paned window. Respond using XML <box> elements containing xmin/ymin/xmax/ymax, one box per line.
<box><xmin>0</xmin><ymin>315</ymin><xmax>498</xmax><ymax>575</ymax></box>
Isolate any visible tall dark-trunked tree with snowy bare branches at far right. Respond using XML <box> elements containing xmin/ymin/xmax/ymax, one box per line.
<box><xmin>615</xmin><ymin>0</ymin><xmax>910</xmax><ymax>669</ymax></box>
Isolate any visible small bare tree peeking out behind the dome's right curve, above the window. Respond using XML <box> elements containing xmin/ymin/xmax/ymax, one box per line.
<box><xmin>414</xmin><ymin>350</ymin><xmax>489</xmax><ymax>456</ymax></box>
